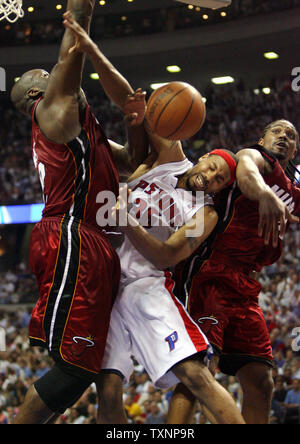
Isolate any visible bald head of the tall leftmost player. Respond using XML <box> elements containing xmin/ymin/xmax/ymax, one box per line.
<box><xmin>10</xmin><ymin>69</ymin><xmax>49</xmax><ymax>115</ymax></box>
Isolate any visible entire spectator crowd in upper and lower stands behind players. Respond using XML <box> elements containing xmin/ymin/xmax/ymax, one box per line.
<box><xmin>0</xmin><ymin>70</ymin><xmax>300</xmax><ymax>424</ymax></box>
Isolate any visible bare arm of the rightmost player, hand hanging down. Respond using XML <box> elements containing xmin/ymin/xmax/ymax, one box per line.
<box><xmin>236</xmin><ymin>149</ymin><xmax>299</xmax><ymax>247</ymax></box>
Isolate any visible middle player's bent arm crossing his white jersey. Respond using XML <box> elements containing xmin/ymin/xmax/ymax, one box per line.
<box><xmin>112</xmin><ymin>188</ymin><xmax>218</xmax><ymax>269</ymax></box>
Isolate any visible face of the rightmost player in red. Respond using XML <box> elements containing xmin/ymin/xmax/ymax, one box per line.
<box><xmin>259</xmin><ymin>121</ymin><xmax>297</xmax><ymax>161</ymax></box>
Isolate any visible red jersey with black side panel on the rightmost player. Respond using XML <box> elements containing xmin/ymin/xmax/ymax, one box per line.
<box><xmin>175</xmin><ymin>145</ymin><xmax>300</xmax><ymax>302</ymax></box>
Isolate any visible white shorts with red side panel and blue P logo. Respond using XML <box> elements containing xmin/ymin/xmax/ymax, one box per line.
<box><xmin>102</xmin><ymin>272</ymin><xmax>209</xmax><ymax>388</ymax></box>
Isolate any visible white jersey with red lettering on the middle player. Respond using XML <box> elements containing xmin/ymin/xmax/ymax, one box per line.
<box><xmin>117</xmin><ymin>159</ymin><xmax>213</xmax><ymax>286</ymax></box>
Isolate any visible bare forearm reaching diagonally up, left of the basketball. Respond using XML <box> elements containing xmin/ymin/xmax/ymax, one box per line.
<box><xmin>87</xmin><ymin>44</ymin><xmax>133</xmax><ymax>109</ymax></box>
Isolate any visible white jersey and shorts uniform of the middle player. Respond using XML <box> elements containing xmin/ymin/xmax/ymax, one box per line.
<box><xmin>102</xmin><ymin>159</ymin><xmax>213</xmax><ymax>388</ymax></box>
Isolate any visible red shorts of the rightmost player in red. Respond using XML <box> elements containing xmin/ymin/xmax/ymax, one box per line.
<box><xmin>189</xmin><ymin>261</ymin><xmax>273</xmax><ymax>375</ymax></box>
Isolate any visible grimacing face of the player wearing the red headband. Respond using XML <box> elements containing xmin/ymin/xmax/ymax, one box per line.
<box><xmin>187</xmin><ymin>156</ymin><xmax>231</xmax><ymax>194</ymax></box>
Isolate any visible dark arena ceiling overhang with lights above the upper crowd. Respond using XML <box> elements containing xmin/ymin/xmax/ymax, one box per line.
<box><xmin>0</xmin><ymin>0</ymin><xmax>300</xmax><ymax>94</ymax></box>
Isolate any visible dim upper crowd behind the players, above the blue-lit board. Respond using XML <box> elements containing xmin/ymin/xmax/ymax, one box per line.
<box><xmin>0</xmin><ymin>78</ymin><xmax>300</xmax><ymax>205</ymax></box>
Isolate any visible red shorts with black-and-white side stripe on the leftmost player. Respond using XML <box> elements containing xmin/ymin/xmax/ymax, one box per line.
<box><xmin>29</xmin><ymin>216</ymin><xmax>120</xmax><ymax>380</ymax></box>
